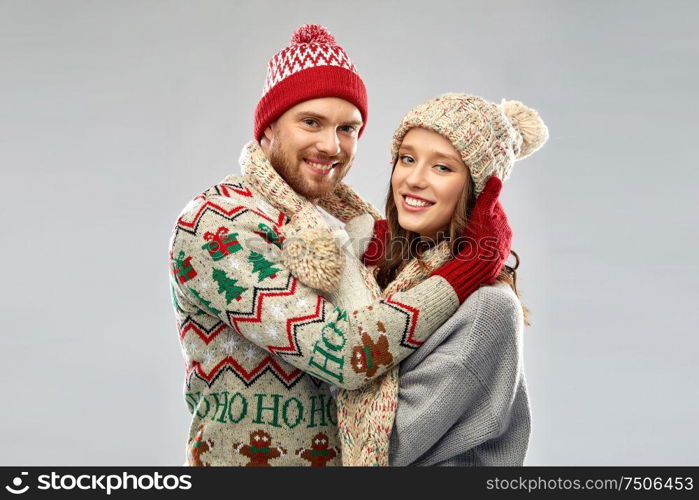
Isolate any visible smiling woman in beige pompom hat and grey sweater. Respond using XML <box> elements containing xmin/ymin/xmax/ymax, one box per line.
<box><xmin>304</xmin><ymin>94</ymin><xmax>548</xmax><ymax>466</ymax></box>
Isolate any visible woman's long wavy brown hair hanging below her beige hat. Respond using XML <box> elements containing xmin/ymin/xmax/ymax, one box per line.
<box><xmin>375</xmin><ymin>160</ymin><xmax>530</xmax><ymax>326</ymax></box>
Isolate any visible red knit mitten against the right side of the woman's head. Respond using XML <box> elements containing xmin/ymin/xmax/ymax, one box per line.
<box><xmin>432</xmin><ymin>176</ymin><xmax>512</xmax><ymax>303</ymax></box>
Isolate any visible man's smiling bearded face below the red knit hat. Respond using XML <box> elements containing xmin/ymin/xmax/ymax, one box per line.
<box><xmin>261</xmin><ymin>97</ymin><xmax>362</xmax><ymax>200</ymax></box>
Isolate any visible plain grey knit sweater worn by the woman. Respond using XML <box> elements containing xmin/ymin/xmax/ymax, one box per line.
<box><xmin>390</xmin><ymin>283</ymin><xmax>531</xmax><ymax>466</ymax></box>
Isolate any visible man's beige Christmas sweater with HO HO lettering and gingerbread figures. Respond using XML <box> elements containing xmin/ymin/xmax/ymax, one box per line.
<box><xmin>170</xmin><ymin>142</ymin><xmax>459</xmax><ymax>466</ymax></box>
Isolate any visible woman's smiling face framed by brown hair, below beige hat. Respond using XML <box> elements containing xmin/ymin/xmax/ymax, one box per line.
<box><xmin>391</xmin><ymin>128</ymin><xmax>471</xmax><ymax>241</ymax></box>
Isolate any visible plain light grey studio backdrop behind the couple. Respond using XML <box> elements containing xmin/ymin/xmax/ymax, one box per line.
<box><xmin>0</xmin><ymin>0</ymin><xmax>699</xmax><ymax>465</ymax></box>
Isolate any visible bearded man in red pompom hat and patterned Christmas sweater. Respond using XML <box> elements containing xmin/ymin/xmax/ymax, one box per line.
<box><xmin>170</xmin><ymin>25</ymin><xmax>509</xmax><ymax>466</ymax></box>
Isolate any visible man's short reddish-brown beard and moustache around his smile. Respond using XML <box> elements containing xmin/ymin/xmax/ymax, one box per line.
<box><xmin>267</xmin><ymin>143</ymin><xmax>351</xmax><ymax>200</ymax></box>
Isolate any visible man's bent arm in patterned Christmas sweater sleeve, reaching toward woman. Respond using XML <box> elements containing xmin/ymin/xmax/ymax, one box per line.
<box><xmin>171</xmin><ymin>191</ymin><xmax>459</xmax><ymax>389</ymax></box>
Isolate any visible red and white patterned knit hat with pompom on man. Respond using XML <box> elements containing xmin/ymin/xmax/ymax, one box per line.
<box><xmin>254</xmin><ymin>24</ymin><xmax>367</xmax><ymax>141</ymax></box>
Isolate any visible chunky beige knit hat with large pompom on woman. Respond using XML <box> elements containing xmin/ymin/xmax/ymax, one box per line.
<box><xmin>391</xmin><ymin>93</ymin><xmax>549</xmax><ymax>195</ymax></box>
